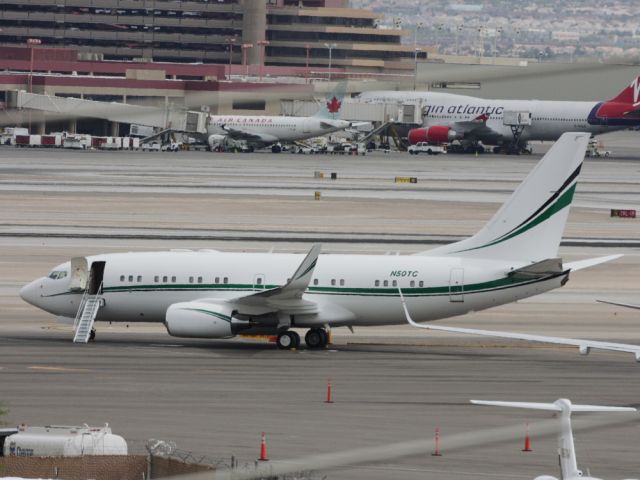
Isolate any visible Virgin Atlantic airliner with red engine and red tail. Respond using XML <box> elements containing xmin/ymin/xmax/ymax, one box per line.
<box><xmin>357</xmin><ymin>77</ymin><xmax>640</xmax><ymax>152</ymax></box>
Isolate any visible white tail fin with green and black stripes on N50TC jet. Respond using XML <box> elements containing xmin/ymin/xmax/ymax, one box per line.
<box><xmin>421</xmin><ymin>133</ymin><xmax>589</xmax><ymax>262</ymax></box>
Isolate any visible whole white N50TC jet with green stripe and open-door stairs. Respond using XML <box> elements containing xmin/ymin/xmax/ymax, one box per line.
<box><xmin>20</xmin><ymin>133</ymin><xmax>619</xmax><ymax>349</ymax></box>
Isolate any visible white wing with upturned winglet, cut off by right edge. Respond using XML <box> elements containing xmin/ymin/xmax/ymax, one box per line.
<box><xmin>398</xmin><ymin>290</ymin><xmax>640</xmax><ymax>362</ymax></box>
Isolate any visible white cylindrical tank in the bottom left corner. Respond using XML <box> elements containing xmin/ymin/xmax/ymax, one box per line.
<box><xmin>3</xmin><ymin>424</ymin><xmax>127</xmax><ymax>457</ymax></box>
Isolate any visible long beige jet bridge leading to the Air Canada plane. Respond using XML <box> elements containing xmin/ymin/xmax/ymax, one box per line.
<box><xmin>16</xmin><ymin>90</ymin><xmax>208</xmax><ymax>134</ymax></box>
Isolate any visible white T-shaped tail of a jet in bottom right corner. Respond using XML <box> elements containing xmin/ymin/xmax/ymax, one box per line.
<box><xmin>471</xmin><ymin>398</ymin><xmax>637</xmax><ymax>480</ymax></box>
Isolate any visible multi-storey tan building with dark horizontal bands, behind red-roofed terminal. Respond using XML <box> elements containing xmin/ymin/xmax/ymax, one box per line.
<box><xmin>0</xmin><ymin>0</ymin><xmax>427</xmax><ymax>73</ymax></box>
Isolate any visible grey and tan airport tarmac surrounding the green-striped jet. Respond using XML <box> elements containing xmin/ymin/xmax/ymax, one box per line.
<box><xmin>0</xmin><ymin>132</ymin><xmax>640</xmax><ymax>480</ymax></box>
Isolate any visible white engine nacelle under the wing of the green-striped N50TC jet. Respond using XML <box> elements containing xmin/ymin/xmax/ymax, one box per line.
<box><xmin>164</xmin><ymin>302</ymin><xmax>248</xmax><ymax>338</ymax></box>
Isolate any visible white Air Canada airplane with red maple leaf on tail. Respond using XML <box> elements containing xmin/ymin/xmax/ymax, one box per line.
<box><xmin>207</xmin><ymin>90</ymin><xmax>351</xmax><ymax>153</ymax></box>
